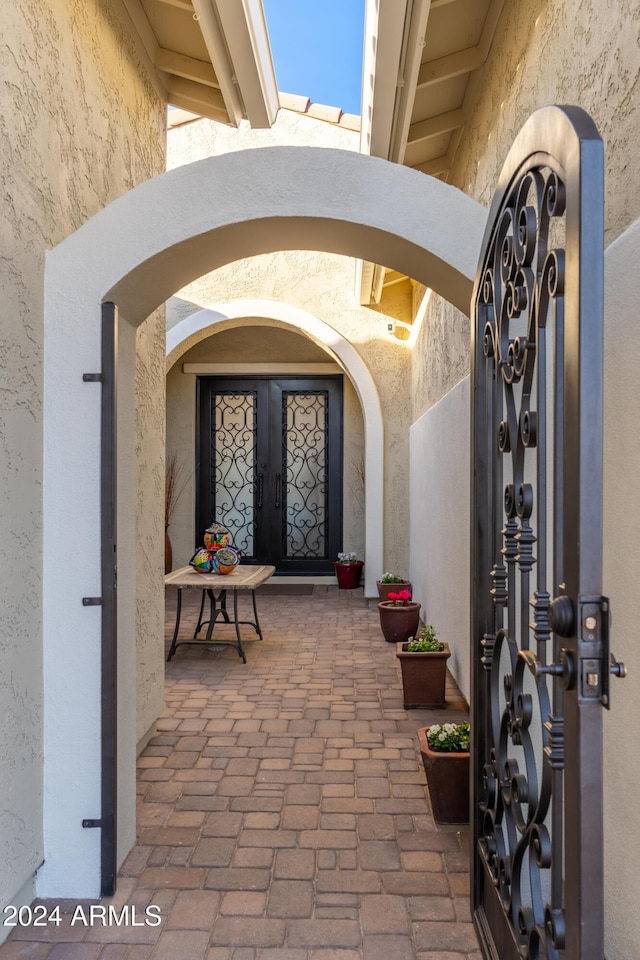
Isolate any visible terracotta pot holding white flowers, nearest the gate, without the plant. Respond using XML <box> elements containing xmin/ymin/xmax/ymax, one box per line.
<box><xmin>418</xmin><ymin>727</ymin><xmax>469</xmax><ymax>823</ymax></box>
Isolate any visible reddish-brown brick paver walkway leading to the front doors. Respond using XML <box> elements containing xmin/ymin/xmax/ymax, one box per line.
<box><xmin>0</xmin><ymin>587</ymin><xmax>480</xmax><ymax>960</ymax></box>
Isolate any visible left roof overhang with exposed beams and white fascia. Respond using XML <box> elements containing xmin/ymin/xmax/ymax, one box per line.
<box><xmin>124</xmin><ymin>0</ymin><xmax>279</xmax><ymax>127</ymax></box>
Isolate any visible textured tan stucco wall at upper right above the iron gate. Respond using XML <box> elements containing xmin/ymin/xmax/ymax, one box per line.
<box><xmin>450</xmin><ymin>0</ymin><xmax>640</xmax><ymax>245</ymax></box>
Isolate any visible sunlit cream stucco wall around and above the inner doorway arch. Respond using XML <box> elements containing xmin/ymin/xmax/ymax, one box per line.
<box><xmin>167</xmin><ymin>110</ymin><xmax>411</xmax><ymax>575</ymax></box>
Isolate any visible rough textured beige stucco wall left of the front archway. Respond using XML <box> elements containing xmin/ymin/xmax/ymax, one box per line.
<box><xmin>0</xmin><ymin>0</ymin><xmax>165</xmax><ymax>916</ymax></box>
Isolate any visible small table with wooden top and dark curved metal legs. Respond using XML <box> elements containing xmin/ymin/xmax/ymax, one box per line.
<box><xmin>164</xmin><ymin>565</ymin><xmax>276</xmax><ymax>663</ymax></box>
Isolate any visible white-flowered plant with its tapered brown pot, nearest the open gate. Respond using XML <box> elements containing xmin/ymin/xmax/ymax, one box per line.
<box><xmin>418</xmin><ymin>721</ymin><xmax>471</xmax><ymax>823</ymax></box>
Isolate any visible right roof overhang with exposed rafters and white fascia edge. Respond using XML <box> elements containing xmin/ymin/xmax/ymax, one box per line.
<box><xmin>357</xmin><ymin>0</ymin><xmax>504</xmax><ymax>304</ymax></box>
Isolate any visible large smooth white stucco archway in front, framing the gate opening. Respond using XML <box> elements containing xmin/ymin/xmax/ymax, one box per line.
<box><xmin>42</xmin><ymin>147</ymin><xmax>486</xmax><ymax>897</ymax></box>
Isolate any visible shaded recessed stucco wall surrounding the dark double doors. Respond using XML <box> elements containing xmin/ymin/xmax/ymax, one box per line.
<box><xmin>167</xmin><ymin>326</ymin><xmax>365</xmax><ymax>569</ymax></box>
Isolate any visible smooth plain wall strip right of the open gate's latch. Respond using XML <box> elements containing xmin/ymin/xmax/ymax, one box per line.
<box><xmin>603</xmin><ymin>220</ymin><xmax>640</xmax><ymax>960</ymax></box>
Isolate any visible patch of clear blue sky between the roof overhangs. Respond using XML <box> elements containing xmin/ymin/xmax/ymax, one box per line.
<box><xmin>262</xmin><ymin>0</ymin><xmax>365</xmax><ymax>114</ymax></box>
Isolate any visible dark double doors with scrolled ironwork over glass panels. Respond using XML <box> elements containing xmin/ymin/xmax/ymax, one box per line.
<box><xmin>196</xmin><ymin>376</ymin><xmax>342</xmax><ymax>574</ymax></box>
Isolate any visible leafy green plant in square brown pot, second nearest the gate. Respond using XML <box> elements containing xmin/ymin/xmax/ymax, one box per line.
<box><xmin>396</xmin><ymin>623</ymin><xmax>451</xmax><ymax>710</ymax></box>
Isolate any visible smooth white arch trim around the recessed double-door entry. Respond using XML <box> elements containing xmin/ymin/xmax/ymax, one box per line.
<box><xmin>167</xmin><ymin>300</ymin><xmax>384</xmax><ymax>596</ymax></box>
